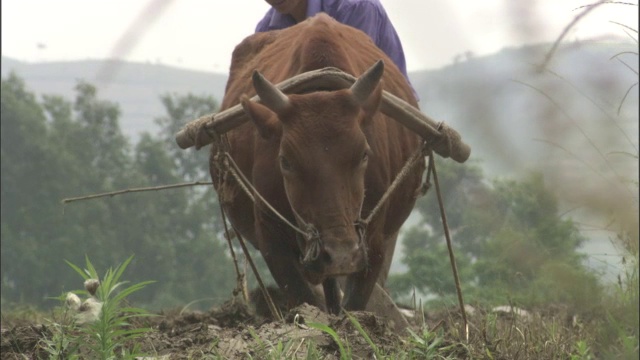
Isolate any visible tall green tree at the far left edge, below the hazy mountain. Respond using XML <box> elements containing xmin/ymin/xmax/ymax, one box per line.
<box><xmin>2</xmin><ymin>75</ymin><xmax>140</xmax><ymax>304</ymax></box>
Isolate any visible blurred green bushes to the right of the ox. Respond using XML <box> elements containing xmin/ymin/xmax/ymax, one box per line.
<box><xmin>389</xmin><ymin>162</ymin><xmax>600</xmax><ymax>311</ymax></box>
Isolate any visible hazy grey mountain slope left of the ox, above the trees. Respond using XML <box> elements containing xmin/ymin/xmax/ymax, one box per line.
<box><xmin>2</xmin><ymin>56</ymin><xmax>227</xmax><ymax>139</ymax></box>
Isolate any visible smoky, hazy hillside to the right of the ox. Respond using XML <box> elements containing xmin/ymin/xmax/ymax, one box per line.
<box><xmin>410</xmin><ymin>39</ymin><xmax>638</xmax><ymax>174</ymax></box>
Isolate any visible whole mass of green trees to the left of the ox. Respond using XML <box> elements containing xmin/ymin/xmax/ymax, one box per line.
<box><xmin>0</xmin><ymin>74</ymin><xmax>234</xmax><ymax>309</ymax></box>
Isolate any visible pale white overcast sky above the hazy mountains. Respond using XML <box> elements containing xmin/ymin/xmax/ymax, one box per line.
<box><xmin>2</xmin><ymin>0</ymin><xmax>638</xmax><ymax>73</ymax></box>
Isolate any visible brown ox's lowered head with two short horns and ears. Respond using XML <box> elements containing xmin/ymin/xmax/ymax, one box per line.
<box><xmin>242</xmin><ymin>61</ymin><xmax>384</xmax><ymax>283</ymax></box>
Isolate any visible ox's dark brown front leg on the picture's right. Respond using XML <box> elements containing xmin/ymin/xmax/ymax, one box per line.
<box><xmin>343</xmin><ymin>236</ymin><xmax>385</xmax><ymax>310</ymax></box>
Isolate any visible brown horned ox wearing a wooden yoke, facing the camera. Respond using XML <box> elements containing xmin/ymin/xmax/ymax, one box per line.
<box><xmin>211</xmin><ymin>14</ymin><xmax>424</xmax><ymax>312</ymax></box>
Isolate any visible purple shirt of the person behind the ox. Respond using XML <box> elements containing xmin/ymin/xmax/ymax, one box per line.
<box><xmin>256</xmin><ymin>0</ymin><xmax>415</xmax><ymax>86</ymax></box>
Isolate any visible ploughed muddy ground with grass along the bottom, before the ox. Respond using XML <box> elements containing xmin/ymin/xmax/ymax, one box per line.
<box><xmin>0</xmin><ymin>288</ymin><xmax>604</xmax><ymax>360</ymax></box>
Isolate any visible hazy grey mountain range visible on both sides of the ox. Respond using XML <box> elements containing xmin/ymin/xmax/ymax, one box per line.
<box><xmin>2</xmin><ymin>39</ymin><xmax>638</xmax><ymax>173</ymax></box>
